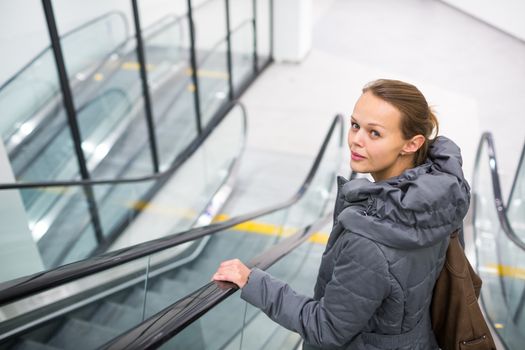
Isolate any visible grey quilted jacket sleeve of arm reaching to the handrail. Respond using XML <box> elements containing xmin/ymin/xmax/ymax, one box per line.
<box><xmin>241</xmin><ymin>233</ymin><xmax>390</xmax><ymax>346</ymax></box>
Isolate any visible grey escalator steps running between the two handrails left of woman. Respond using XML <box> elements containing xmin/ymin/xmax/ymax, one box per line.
<box><xmin>5</xmin><ymin>231</ymin><xmax>271</xmax><ymax>349</ymax></box>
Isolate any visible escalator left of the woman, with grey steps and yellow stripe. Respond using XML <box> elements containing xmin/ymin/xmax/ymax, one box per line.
<box><xmin>0</xmin><ymin>116</ymin><xmax>343</xmax><ymax>349</ymax></box>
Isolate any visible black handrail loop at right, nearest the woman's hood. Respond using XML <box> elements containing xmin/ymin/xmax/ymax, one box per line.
<box><xmin>473</xmin><ymin>132</ymin><xmax>525</xmax><ymax>250</ymax></box>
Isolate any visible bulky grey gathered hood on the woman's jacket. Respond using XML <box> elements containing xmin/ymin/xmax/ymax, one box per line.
<box><xmin>336</xmin><ymin>136</ymin><xmax>470</xmax><ymax>249</ymax></box>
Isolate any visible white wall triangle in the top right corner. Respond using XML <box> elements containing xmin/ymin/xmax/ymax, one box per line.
<box><xmin>442</xmin><ymin>0</ymin><xmax>525</xmax><ymax>40</ymax></box>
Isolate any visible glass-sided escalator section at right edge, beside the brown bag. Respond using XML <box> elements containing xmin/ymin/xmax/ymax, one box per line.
<box><xmin>473</xmin><ymin>135</ymin><xmax>525</xmax><ymax>349</ymax></box>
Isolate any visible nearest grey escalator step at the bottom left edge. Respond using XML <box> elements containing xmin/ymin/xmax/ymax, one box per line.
<box><xmin>49</xmin><ymin>318</ymin><xmax>120</xmax><ymax>350</ymax></box>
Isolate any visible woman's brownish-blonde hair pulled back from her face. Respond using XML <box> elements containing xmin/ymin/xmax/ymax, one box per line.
<box><xmin>363</xmin><ymin>79</ymin><xmax>439</xmax><ymax>166</ymax></box>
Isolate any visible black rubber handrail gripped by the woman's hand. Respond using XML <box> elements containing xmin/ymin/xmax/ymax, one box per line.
<box><xmin>101</xmin><ymin>212</ymin><xmax>333</xmax><ymax>350</ymax></box>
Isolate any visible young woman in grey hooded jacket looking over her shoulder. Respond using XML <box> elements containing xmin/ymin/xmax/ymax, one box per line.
<box><xmin>213</xmin><ymin>80</ymin><xmax>470</xmax><ymax>350</ymax></box>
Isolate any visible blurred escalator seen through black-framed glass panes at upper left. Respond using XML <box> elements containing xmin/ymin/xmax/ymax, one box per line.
<box><xmin>0</xmin><ymin>1</ymin><xmax>262</xmax><ymax>268</ymax></box>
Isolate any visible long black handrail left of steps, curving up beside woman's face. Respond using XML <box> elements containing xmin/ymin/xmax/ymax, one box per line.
<box><xmin>0</xmin><ymin>114</ymin><xmax>344</xmax><ymax>305</ymax></box>
